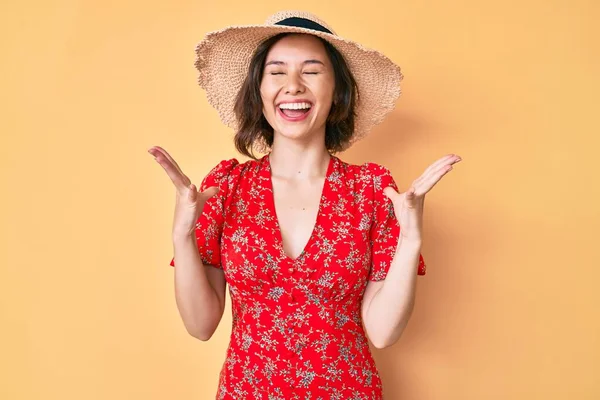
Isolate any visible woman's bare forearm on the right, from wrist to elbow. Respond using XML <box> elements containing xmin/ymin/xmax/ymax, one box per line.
<box><xmin>367</xmin><ymin>239</ymin><xmax>421</xmax><ymax>348</ymax></box>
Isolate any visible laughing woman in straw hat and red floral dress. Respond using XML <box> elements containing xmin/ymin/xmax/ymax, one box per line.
<box><xmin>149</xmin><ymin>12</ymin><xmax>460</xmax><ymax>400</ymax></box>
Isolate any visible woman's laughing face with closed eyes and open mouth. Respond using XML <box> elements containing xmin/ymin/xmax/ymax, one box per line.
<box><xmin>260</xmin><ymin>35</ymin><xmax>335</xmax><ymax>139</ymax></box>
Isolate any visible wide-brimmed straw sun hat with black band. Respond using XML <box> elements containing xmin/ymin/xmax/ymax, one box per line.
<box><xmin>195</xmin><ymin>11</ymin><xmax>403</xmax><ymax>148</ymax></box>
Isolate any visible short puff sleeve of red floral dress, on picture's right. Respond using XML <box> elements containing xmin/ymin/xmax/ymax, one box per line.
<box><xmin>365</xmin><ymin>163</ymin><xmax>426</xmax><ymax>281</ymax></box>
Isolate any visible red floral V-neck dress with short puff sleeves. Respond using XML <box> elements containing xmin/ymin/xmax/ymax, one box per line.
<box><xmin>170</xmin><ymin>154</ymin><xmax>425</xmax><ymax>400</ymax></box>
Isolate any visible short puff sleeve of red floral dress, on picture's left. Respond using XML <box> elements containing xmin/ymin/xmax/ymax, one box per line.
<box><xmin>169</xmin><ymin>158</ymin><xmax>239</xmax><ymax>268</ymax></box>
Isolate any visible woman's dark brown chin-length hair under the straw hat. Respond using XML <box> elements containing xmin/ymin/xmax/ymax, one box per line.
<box><xmin>234</xmin><ymin>33</ymin><xmax>358</xmax><ymax>159</ymax></box>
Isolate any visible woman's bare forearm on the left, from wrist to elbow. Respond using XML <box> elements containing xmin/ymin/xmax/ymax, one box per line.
<box><xmin>173</xmin><ymin>236</ymin><xmax>222</xmax><ymax>340</ymax></box>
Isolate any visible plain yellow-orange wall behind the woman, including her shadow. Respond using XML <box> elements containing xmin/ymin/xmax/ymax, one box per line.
<box><xmin>0</xmin><ymin>0</ymin><xmax>600</xmax><ymax>400</ymax></box>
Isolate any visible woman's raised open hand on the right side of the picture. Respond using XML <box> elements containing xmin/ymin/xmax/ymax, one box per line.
<box><xmin>383</xmin><ymin>154</ymin><xmax>461</xmax><ymax>241</ymax></box>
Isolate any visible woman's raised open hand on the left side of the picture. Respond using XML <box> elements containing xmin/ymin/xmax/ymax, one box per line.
<box><xmin>148</xmin><ymin>146</ymin><xmax>219</xmax><ymax>238</ymax></box>
